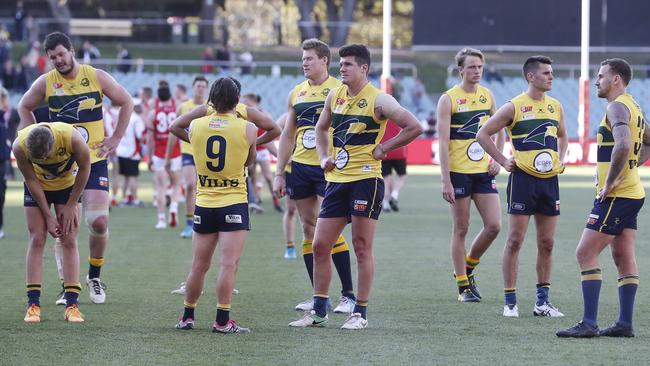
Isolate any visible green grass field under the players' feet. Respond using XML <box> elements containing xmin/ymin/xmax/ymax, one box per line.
<box><xmin>0</xmin><ymin>168</ymin><xmax>650</xmax><ymax>365</ymax></box>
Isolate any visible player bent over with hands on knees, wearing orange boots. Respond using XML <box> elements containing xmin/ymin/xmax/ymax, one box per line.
<box><xmin>13</xmin><ymin>122</ymin><xmax>90</xmax><ymax>323</ymax></box>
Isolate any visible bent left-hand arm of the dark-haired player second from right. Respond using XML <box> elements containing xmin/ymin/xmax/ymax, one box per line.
<box><xmin>476</xmin><ymin>102</ymin><xmax>516</xmax><ymax>172</ymax></box>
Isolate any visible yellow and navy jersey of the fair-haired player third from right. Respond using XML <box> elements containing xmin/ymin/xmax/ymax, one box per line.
<box><xmin>445</xmin><ymin>85</ymin><xmax>494</xmax><ymax>174</ymax></box>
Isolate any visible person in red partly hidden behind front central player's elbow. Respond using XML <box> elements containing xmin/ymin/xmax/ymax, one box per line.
<box><xmin>381</xmin><ymin>120</ymin><xmax>406</xmax><ymax>211</ymax></box>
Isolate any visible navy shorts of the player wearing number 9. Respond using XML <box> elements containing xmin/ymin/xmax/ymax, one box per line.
<box><xmin>193</xmin><ymin>203</ymin><xmax>250</xmax><ymax>234</ymax></box>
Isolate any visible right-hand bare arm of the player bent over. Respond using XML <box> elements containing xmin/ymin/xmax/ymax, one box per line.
<box><xmin>57</xmin><ymin>129</ymin><xmax>90</xmax><ymax>235</ymax></box>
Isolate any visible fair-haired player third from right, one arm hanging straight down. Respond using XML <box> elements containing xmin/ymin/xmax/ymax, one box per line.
<box><xmin>438</xmin><ymin>48</ymin><xmax>505</xmax><ymax>302</ymax></box>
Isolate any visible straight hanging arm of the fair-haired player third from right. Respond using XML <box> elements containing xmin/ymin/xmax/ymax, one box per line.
<box><xmin>437</xmin><ymin>93</ymin><xmax>456</xmax><ymax>204</ymax></box>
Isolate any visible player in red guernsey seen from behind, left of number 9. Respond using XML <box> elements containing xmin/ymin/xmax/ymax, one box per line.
<box><xmin>146</xmin><ymin>82</ymin><xmax>181</xmax><ymax>229</ymax></box>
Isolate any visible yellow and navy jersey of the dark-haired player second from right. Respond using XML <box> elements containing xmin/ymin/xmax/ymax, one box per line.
<box><xmin>507</xmin><ymin>93</ymin><xmax>562</xmax><ymax>178</ymax></box>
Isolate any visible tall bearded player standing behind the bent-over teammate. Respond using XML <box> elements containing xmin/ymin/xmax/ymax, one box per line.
<box><xmin>18</xmin><ymin>32</ymin><xmax>133</xmax><ymax>304</ymax></box>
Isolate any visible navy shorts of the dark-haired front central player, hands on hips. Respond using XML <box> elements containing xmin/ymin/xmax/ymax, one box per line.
<box><xmin>318</xmin><ymin>178</ymin><xmax>384</xmax><ymax>220</ymax></box>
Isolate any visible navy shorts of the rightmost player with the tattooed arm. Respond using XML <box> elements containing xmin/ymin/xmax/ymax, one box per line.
<box><xmin>586</xmin><ymin>197</ymin><xmax>645</xmax><ymax>235</ymax></box>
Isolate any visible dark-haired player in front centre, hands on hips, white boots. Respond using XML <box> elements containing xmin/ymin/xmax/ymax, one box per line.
<box><xmin>289</xmin><ymin>44</ymin><xmax>422</xmax><ymax>329</ymax></box>
